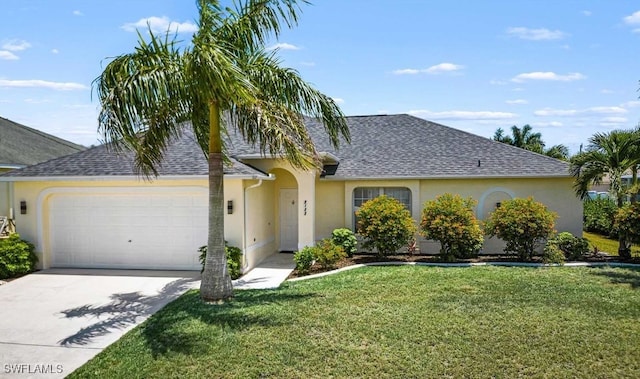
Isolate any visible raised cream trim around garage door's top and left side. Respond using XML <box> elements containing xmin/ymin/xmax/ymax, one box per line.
<box><xmin>35</xmin><ymin>186</ymin><xmax>209</xmax><ymax>268</ymax></box>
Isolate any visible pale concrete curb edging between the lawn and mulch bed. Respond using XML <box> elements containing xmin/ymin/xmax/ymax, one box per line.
<box><xmin>286</xmin><ymin>262</ymin><xmax>640</xmax><ymax>282</ymax></box>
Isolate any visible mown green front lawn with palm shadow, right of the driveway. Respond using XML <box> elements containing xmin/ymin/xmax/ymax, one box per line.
<box><xmin>71</xmin><ymin>266</ymin><xmax>640</xmax><ymax>378</ymax></box>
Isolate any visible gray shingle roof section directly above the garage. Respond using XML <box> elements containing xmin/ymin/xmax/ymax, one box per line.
<box><xmin>0</xmin><ymin>128</ymin><xmax>265</xmax><ymax>178</ymax></box>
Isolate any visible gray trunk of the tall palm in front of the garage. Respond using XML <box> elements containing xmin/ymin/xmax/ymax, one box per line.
<box><xmin>200</xmin><ymin>102</ymin><xmax>233</xmax><ymax>301</ymax></box>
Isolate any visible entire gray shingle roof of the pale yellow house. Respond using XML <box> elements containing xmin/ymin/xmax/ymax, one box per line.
<box><xmin>4</xmin><ymin>114</ymin><xmax>569</xmax><ymax>179</ymax></box>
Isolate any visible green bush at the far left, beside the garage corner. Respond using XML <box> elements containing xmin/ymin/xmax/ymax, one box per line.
<box><xmin>0</xmin><ymin>233</ymin><xmax>38</xmax><ymax>279</ymax></box>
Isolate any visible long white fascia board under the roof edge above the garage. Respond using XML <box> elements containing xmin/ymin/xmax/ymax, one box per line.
<box><xmin>0</xmin><ymin>174</ymin><xmax>275</xmax><ymax>182</ymax></box>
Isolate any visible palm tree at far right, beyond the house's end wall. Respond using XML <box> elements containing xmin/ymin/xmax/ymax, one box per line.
<box><xmin>571</xmin><ymin>130</ymin><xmax>640</xmax><ymax>257</ymax></box>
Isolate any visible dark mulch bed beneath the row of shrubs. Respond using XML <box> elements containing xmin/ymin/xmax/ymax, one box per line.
<box><xmin>288</xmin><ymin>253</ymin><xmax>640</xmax><ymax>279</ymax></box>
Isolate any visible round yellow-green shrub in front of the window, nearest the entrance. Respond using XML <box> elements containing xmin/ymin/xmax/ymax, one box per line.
<box><xmin>356</xmin><ymin>195</ymin><xmax>416</xmax><ymax>256</ymax></box>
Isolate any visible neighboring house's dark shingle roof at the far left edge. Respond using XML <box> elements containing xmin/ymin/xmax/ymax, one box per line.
<box><xmin>0</xmin><ymin>117</ymin><xmax>85</xmax><ymax>167</ymax></box>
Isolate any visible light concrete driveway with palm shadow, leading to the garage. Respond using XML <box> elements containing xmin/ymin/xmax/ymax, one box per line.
<box><xmin>0</xmin><ymin>269</ymin><xmax>200</xmax><ymax>378</ymax></box>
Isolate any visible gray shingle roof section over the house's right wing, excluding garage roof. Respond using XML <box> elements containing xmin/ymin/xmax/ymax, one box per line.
<box><xmin>234</xmin><ymin>114</ymin><xmax>569</xmax><ymax>179</ymax></box>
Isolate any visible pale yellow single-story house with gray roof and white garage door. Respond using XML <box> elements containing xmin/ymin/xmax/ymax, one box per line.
<box><xmin>0</xmin><ymin>114</ymin><xmax>582</xmax><ymax>270</ymax></box>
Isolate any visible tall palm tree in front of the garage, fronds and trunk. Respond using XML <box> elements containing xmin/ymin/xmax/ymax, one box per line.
<box><xmin>94</xmin><ymin>0</ymin><xmax>349</xmax><ymax>301</ymax></box>
